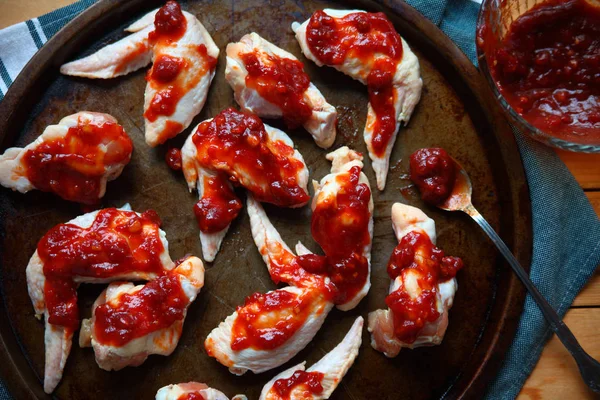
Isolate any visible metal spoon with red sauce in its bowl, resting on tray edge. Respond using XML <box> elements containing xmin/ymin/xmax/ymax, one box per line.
<box><xmin>410</xmin><ymin>148</ymin><xmax>600</xmax><ymax>393</ymax></box>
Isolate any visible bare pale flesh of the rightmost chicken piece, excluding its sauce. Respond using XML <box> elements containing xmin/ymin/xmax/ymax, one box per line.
<box><xmin>368</xmin><ymin>203</ymin><xmax>458</xmax><ymax>357</ymax></box>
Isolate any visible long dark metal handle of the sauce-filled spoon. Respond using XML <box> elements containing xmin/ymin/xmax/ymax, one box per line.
<box><xmin>464</xmin><ymin>205</ymin><xmax>600</xmax><ymax>392</ymax></box>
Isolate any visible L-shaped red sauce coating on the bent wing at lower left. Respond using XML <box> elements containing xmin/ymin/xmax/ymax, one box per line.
<box><xmin>37</xmin><ymin>208</ymin><xmax>164</xmax><ymax>329</ymax></box>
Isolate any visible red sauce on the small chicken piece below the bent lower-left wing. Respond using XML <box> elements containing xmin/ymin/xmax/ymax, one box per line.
<box><xmin>94</xmin><ymin>272</ymin><xmax>189</xmax><ymax>346</ymax></box>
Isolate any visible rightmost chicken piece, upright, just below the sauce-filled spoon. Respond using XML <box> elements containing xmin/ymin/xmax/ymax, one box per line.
<box><xmin>368</xmin><ymin>203</ymin><xmax>463</xmax><ymax>357</ymax></box>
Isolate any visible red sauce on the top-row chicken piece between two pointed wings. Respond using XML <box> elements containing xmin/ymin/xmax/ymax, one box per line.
<box><xmin>240</xmin><ymin>50</ymin><xmax>312</xmax><ymax>128</ymax></box>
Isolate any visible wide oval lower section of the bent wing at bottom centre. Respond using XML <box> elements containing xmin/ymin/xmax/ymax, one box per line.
<box><xmin>204</xmin><ymin>286</ymin><xmax>333</xmax><ymax>375</ymax></box>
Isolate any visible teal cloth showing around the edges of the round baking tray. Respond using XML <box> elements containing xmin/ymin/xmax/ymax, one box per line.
<box><xmin>0</xmin><ymin>0</ymin><xmax>600</xmax><ymax>400</ymax></box>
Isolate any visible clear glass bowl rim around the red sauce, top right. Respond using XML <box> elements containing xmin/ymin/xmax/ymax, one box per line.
<box><xmin>476</xmin><ymin>0</ymin><xmax>600</xmax><ymax>153</ymax></box>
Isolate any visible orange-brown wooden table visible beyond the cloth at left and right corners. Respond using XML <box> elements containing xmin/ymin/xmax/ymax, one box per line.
<box><xmin>0</xmin><ymin>0</ymin><xmax>600</xmax><ymax>400</ymax></box>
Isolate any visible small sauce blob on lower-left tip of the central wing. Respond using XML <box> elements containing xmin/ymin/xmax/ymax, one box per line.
<box><xmin>194</xmin><ymin>175</ymin><xmax>242</xmax><ymax>233</ymax></box>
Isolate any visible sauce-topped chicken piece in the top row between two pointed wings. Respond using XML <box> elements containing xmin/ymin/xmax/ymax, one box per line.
<box><xmin>225</xmin><ymin>32</ymin><xmax>337</xmax><ymax>148</ymax></box>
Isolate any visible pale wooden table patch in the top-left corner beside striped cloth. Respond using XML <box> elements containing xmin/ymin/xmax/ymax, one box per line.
<box><xmin>0</xmin><ymin>0</ymin><xmax>77</xmax><ymax>29</ymax></box>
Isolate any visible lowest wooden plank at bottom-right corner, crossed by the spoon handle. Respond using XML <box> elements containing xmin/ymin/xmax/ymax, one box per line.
<box><xmin>517</xmin><ymin>308</ymin><xmax>600</xmax><ymax>400</ymax></box>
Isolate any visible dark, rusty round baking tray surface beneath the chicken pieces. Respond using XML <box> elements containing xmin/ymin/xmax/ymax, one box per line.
<box><xmin>0</xmin><ymin>0</ymin><xmax>532</xmax><ymax>400</ymax></box>
